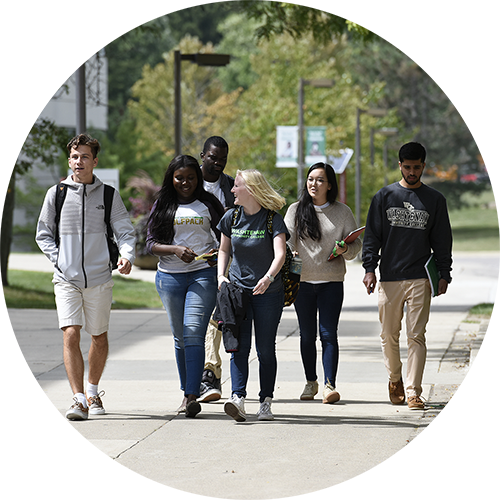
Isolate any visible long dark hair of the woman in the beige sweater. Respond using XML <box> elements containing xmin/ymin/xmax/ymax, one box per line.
<box><xmin>295</xmin><ymin>163</ymin><xmax>339</xmax><ymax>241</ymax></box>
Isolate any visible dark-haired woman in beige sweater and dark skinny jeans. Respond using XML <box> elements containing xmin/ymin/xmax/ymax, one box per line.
<box><xmin>285</xmin><ymin>163</ymin><xmax>361</xmax><ymax>404</ymax></box>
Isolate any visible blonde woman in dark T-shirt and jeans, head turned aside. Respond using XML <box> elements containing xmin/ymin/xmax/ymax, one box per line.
<box><xmin>217</xmin><ymin>170</ymin><xmax>289</xmax><ymax>422</ymax></box>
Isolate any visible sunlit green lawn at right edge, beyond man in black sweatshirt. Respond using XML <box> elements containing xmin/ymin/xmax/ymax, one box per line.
<box><xmin>450</xmin><ymin>184</ymin><xmax>500</xmax><ymax>251</ymax></box>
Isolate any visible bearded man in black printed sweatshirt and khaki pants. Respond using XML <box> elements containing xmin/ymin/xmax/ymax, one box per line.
<box><xmin>363</xmin><ymin>142</ymin><xmax>452</xmax><ymax>410</ymax></box>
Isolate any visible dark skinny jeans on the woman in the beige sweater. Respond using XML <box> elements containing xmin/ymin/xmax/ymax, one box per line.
<box><xmin>294</xmin><ymin>281</ymin><xmax>344</xmax><ymax>387</ymax></box>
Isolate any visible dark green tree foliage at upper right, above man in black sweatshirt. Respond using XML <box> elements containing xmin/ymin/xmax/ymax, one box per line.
<box><xmin>336</xmin><ymin>39</ymin><xmax>479</xmax><ymax>174</ymax></box>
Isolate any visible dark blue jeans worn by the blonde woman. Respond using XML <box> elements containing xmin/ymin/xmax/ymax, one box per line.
<box><xmin>231</xmin><ymin>288</ymin><xmax>284</xmax><ymax>402</ymax></box>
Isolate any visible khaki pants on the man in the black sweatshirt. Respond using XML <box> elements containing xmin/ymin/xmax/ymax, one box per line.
<box><xmin>378</xmin><ymin>278</ymin><xmax>431</xmax><ymax>397</ymax></box>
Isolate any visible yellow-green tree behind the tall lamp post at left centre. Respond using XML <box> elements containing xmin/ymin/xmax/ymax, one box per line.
<box><xmin>128</xmin><ymin>36</ymin><xmax>240</xmax><ymax>173</ymax></box>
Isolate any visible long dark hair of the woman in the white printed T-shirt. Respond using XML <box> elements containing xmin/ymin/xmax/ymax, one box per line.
<box><xmin>148</xmin><ymin>155</ymin><xmax>224</xmax><ymax>245</ymax></box>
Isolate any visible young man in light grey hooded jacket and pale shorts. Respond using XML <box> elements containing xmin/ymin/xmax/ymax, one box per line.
<box><xmin>36</xmin><ymin>134</ymin><xmax>135</xmax><ymax>420</ymax></box>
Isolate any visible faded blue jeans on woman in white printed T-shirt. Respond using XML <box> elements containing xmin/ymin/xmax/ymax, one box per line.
<box><xmin>156</xmin><ymin>267</ymin><xmax>217</xmax><ymax>396</ymax></box>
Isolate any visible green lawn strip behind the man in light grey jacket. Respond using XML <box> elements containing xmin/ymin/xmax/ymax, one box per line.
<box><xmin>0</xmin><ymin>270</ymin><xmax>163</xmax><ymax>309</ymax></box>
